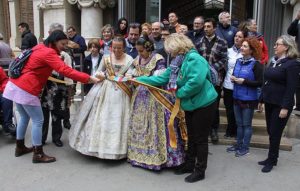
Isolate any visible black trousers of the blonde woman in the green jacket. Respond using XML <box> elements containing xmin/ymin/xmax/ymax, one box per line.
<box><xmin>185</xmin><ymin>102</ymin><xmax>217</xmax><ymax>172</ymax></box>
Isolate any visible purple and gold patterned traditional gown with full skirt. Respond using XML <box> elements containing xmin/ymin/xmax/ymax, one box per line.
<box><xmin>127</xmin><ymin>54</ymin><xmax>184</xmax><ymax>170</ymax></box>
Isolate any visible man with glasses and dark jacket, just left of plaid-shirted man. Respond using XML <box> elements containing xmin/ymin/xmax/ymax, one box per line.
<box><xmin>186</xmin><ymin>16</ymin><xmax>204</xmax><ymax>44</ymax></box>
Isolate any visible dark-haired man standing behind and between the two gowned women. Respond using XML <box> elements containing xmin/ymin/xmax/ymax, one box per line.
<box><xmin>126</xmin><ymin>23</ymin><xmax>141</xmax><ymax>59</ymax></box>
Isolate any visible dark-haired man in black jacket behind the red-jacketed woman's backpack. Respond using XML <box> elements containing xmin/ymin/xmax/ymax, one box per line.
<box><xmin>18</xmin><ymin>23</ymin><xmax>37</xmax><ymax>50</ymax></box>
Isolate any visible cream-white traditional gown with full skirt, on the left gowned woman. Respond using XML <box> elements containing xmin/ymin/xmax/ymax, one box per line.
<box><xmin>69</xmin><ymin>54</ymin><xmax>133</xmax><ymax>159</ymax></box>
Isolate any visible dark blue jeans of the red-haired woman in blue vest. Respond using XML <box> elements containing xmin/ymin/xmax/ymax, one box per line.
<box><xmin>234</xmin><ymin>104</ymin><xmax>254</xmax><ymax>149</ymax></box>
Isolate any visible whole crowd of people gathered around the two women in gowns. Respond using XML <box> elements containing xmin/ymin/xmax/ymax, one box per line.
<box><xmin>0</xmin><ymin>11</ymin><xmax>300</xmax><ymax>183</ymax></box>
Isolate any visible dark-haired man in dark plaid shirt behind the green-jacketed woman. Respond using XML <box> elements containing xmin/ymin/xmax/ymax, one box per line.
<box><xmin>196</xmin><ymin>18</ymin><xmax>227</xmax><ymax>143</ymax></box>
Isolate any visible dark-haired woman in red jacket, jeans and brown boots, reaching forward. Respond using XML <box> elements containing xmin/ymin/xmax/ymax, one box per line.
<box><xmin>3</xmin><ymin>30</ymin><xmax>99</xmax><ymax>163</ymax></box>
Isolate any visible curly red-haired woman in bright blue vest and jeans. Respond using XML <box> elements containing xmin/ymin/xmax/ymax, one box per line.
<box><xmin>227</xmin><ymin>37</ymin><xmax>263</xmax><ymax>157</ymax></box>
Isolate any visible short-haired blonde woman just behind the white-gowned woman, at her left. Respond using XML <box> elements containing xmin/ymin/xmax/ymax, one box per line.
<box><xmin>99</xmin><ymin>24</ymin><xmax>114</xmax><ymax>55</ymax></box>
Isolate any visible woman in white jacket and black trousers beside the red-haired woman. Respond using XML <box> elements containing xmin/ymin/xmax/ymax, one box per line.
<box><xmin>223</xmin><ymin>31</ymin><xmax>247</xmax><ymax>138</ymax></box>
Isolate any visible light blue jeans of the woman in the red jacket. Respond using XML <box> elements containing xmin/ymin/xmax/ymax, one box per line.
<box><xmin>16</xmin><ymin>103</ymin><xmax>44</xmax><ymax>146</ymax></box>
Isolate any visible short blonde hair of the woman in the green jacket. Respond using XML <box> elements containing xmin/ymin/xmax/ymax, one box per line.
<box><xmin>165</xmin><ymin>33</ymin><xmax>195</xmax><ymax>55</ymax></box>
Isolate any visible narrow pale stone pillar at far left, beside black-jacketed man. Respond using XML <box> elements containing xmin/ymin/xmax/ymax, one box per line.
<box><xmin>8</xmin><ymin>0</ymin><xmax>21</xmax><ymax>48</ymax></box>
